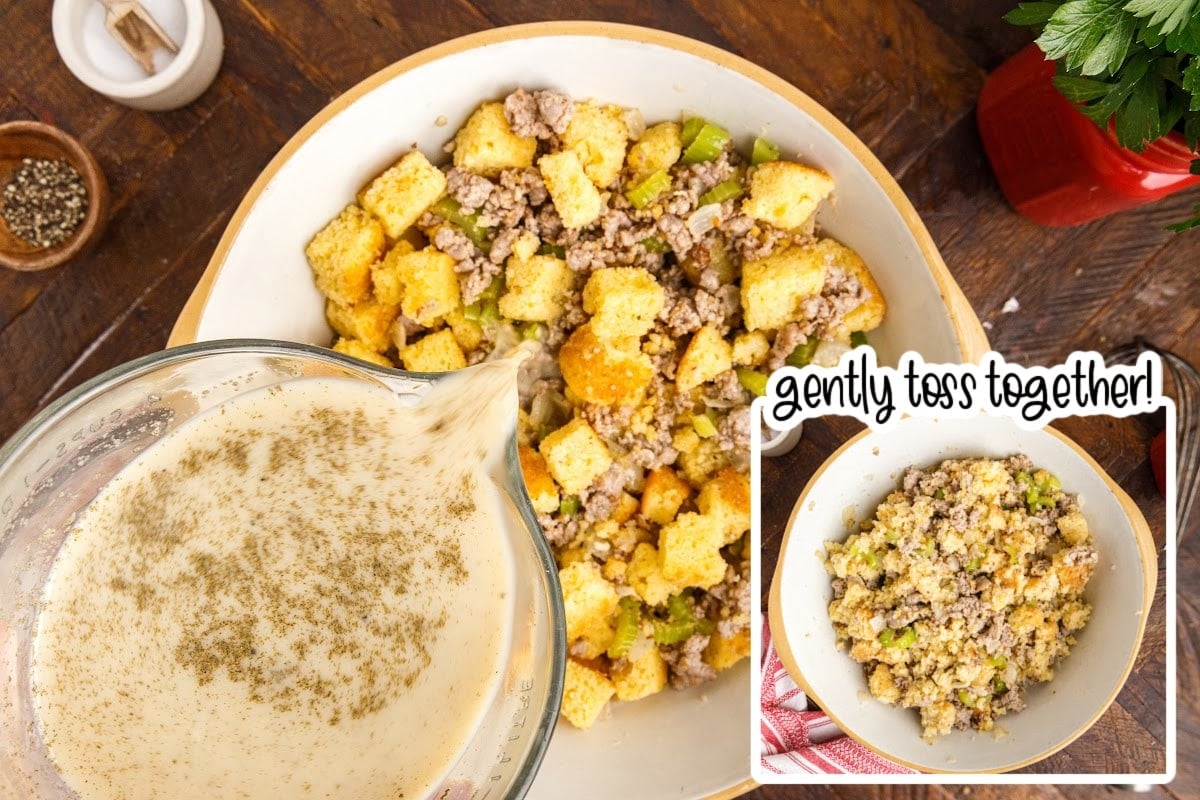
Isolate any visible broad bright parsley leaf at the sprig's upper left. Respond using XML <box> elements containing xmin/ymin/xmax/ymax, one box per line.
<box><xmin>1037</xmin><ymin>0</ymin><xmax>1133</xmax><ymax>74</ymax></box>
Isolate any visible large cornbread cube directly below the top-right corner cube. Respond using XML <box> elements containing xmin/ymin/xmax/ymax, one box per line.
<box><xmin>742</xmin><ymin>245</ymin><xmax>828</xmax><ymax>331</ymax></box>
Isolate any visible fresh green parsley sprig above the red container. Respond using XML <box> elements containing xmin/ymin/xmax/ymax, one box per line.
<box><xmin>1004</xmin><ymin>0</ymin><xmax>1200</xmax><ymax>230</ymax></box>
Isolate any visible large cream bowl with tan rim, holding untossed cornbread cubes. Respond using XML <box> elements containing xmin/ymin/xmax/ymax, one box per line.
<box><xmin>172</xmin><ymin>23</ymin><xmax>988</xmax><ymax>800</ymax></box>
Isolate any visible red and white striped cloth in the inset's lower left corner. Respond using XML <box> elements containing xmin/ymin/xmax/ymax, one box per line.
<box><xmin>760</xmin><ymin>620</ymin><xmax>912</xmax><ymax>775</ymax></box>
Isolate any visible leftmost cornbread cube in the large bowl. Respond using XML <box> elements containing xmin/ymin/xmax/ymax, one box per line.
<box><xmin>304</xmin><ymin>205</ymin><xmax>384</xmax><ymax>306</ymax></box>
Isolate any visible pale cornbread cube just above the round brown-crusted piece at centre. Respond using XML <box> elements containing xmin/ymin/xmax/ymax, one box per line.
<box><xmin>583</xmin><ymin>266</ymin><xmax>665</xmax><ymax>339</ymax></box>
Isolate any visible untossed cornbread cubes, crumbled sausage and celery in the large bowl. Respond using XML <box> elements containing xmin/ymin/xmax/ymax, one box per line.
<box><xmin>306</xmin><ymin>90</ymin><xmax>886</xmax><ymax>728</ymax></box>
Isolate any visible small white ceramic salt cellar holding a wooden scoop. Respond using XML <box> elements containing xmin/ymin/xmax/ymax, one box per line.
<box><xmin>52</xmin><ymin>0</ymin><xmax>224</xmax><ymax>112</ymax></box>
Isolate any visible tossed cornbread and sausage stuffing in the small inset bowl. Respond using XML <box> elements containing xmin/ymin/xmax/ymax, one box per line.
<box><xmin>826</xmin><ymin>455</ymin><xmax>1097</xmax><ymax>739</ymax></box>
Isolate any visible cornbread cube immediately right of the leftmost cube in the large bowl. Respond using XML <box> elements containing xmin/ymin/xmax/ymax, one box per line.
<box><xmin>374</xmin><ymin>245</ymin><xmax>462</xmax><ymax>327</ymax></box>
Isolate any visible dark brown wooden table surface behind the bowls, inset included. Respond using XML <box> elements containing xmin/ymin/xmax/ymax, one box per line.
<box><xmin>0</xmin><ymin>0</ymin><xmax>1200</xmax><ymax>800</ymax></box>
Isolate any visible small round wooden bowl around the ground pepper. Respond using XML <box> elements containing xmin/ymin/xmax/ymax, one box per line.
<box><xmin>0</xmin><ymin>120</ymin><xmax>108</xmax><ymax>271</ymax></box>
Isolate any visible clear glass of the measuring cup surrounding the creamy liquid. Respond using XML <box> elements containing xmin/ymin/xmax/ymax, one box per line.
<box><xmin>0</xmin><ymin>339</ymin><xmax>565</xmax><ymax>800</ymax></box>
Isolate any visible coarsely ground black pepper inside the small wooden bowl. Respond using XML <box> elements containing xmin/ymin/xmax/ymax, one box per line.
<box><xmin>0</xmin><ymin>158</ymin><xmax>88</xmax><ymax>248</ymax></box>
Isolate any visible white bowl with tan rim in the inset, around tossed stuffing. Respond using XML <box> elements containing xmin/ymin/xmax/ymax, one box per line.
<box><xmin>769</xmin><ymin>416</ymin><xmax>1158</xmax><ymax>772</ymax></box>
